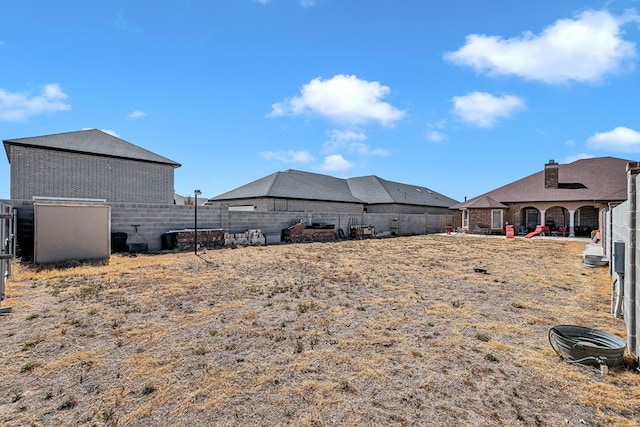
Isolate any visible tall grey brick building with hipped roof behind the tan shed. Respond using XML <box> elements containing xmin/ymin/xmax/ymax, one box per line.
<box><xmin>3</xmin><ymin>129</ymin><xmax>180</xmax><ymax>204</ymax></box>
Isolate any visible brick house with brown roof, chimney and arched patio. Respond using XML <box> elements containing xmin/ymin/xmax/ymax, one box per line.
<box><xmin>450</xmin><ymin>157</ymin><xmax>630</xmax><ymax>236</ymax></box>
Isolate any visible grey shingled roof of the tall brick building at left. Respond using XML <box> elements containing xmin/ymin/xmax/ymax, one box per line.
<box><xmin>2</xmin><ymin>129</ymin><xmax>181</xmax><ymax>167</ymax></box>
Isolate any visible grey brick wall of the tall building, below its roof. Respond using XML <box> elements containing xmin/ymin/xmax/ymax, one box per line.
<box><xmin>11</xmin><ymin>146</ymin><xmax>174</xmax><ymax>204</ymax></box>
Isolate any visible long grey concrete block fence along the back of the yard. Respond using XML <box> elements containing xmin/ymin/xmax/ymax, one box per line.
<box><xmin>4</xmin><ymin>200</ymin><xmax>453</xmax><ymax>258</ymax></box>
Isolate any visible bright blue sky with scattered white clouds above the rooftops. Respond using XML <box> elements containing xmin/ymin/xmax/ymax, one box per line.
<box><xmin>0</xmin><ymin>0</ymin><xmax>640</xmax><ymax>200</ymax></box>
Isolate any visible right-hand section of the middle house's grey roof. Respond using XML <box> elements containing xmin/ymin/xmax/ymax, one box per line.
<box><xmin>347</xmin><ymin>175</ymin><xmax>457</xmax><ymax>208</ymax></box>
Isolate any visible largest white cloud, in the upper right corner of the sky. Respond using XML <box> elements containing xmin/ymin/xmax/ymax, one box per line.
<box><xmin>444</xmin><ymin>11</ymin><xmax>640</xmax><ymax>84</ymax></box>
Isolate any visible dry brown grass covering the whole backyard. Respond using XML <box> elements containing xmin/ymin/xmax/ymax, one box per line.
<box><xmin>0</xmin><ymin>236</ymin><xmax>640</xmax><ymax>426</ymax></box>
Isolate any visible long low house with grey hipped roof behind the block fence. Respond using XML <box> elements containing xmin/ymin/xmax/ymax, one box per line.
<box><xmin>207</xmin><ymin>169</ymin><xmax>456</xmax><ymax>214</ymax></box>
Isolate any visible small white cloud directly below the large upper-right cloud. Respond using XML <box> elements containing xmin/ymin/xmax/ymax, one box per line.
<box><xmin>452</xmin><ymin>92</ymin><xmax>525</xmax><ymax>127</ymax></box>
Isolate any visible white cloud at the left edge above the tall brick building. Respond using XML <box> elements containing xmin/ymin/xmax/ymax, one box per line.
<box><xmin>0</xmin><ymin>83</ymin><xmax>71</xmax><ymax>122</ymax></box>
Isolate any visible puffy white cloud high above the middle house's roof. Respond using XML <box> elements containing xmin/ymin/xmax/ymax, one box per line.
<box><xmin>269</xmin><ymin>74</ymin><xmax>405</xmax><ymax>126</ymax></box>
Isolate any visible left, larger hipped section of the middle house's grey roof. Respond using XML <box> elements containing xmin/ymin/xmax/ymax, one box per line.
<box><xmin>210</xmin><ymin>169</ymin><xmax>364</xmax><ymax>203</ymax></box>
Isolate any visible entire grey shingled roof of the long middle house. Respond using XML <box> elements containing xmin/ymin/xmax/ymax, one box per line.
<box><xmin>211</xmin><ymin>169</ymin><xmax>456</xmax><ymax>207</ymax></box>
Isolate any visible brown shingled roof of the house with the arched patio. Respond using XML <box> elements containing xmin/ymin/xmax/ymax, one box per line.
<box><xmin>451</xmin><ymin>157</ymin><xmax>631</xmax><ymax>209</ymax></box>
